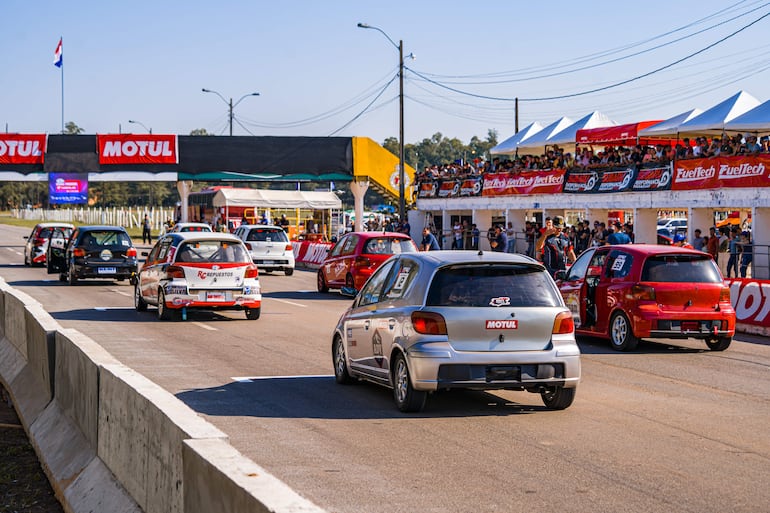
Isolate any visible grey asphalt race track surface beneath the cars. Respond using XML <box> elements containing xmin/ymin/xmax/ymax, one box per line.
<box><xmin>0</xmin><ymin>225</ymin><xmax>770</xmax><ymax>513</ymax></box>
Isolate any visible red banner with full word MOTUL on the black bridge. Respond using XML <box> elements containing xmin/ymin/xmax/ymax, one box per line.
<box><xmin>96</xmin><ymin>134</ymin><xmax>179</xmax><ymax>164</ymax></box>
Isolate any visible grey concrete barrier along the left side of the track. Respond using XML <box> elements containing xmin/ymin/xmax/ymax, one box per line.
<box><xmin>0</xmin><ymin>278</ymin><xmax>323</xmax><ymax>513</ymax></box>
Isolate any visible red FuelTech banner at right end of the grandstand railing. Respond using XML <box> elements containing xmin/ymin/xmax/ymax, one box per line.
<box><xmin>671</xmin><ymin>155</ymin><xmax>770</xmax><ymax>191</ymax></box>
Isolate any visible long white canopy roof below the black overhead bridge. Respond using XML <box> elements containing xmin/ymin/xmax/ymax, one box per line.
<box><xmin>213</xmin><ymin>189</ymin><xmax>342</xmax><ymax>210</ymax></box>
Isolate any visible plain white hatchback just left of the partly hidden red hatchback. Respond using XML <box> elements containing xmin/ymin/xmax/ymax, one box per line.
<box><xmin>235</xmin><ymin>224</ymin><xmax>294</xmax><ymax>276</ymax></box>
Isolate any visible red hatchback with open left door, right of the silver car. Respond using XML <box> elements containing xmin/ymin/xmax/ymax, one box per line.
<box><xmin>555</xmin><ymin>244</ymin><xmax>735</xmax><ymax>351</ymax></box>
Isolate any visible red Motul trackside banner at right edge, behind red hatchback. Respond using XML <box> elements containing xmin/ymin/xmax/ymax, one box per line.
<box><xmin>725</xmin><ymin>278</ymin><xmax>770</xmax><ymax>335</ymax></box>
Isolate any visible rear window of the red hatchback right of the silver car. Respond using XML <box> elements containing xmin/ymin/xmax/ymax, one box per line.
<box><xmin>642</xmin><ymin>255</ymin><xmax>722</xmax><ymax>283</ymax></box>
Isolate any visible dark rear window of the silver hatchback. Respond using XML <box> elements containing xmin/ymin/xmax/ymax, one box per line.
<box><xmin>426</xmin><ymin>264</ymin><xmax>561</xmax><ymax>307</ymax></box>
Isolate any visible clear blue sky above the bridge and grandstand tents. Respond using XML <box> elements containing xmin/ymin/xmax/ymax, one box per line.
<box><xmin>0</xmin><ymin>0</ymin><xmax>770</xmax><ymax>143</ymax></box>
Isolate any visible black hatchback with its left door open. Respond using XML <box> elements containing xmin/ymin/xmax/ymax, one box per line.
<box><xmin>47</xmin><ymin>225</ymin><xmax>137</xmax><ymax>285</ymax></box>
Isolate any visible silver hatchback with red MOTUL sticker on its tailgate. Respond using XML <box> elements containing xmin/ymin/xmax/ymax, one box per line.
<box><xmin>331</xmin><ymin>251</ymin><xmax>580</xmax><ymax>412</ymax></box>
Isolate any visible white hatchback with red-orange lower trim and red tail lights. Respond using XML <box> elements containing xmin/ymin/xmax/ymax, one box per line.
<box><xmin>134</xmin><ymin>232</ymin><xmax>262</xmax><ymax>320</ymax></box>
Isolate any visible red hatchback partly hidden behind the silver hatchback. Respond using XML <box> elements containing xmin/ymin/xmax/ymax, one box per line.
<box><xmin>318</xmin><ymin>232</ymin><xmax>418</xmax><ymax>292</ymax></box>
